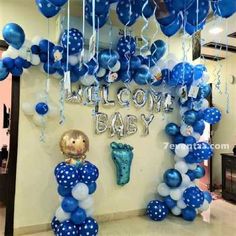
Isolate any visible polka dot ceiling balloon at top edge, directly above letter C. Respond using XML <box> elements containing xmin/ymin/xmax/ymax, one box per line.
<box><xmin>116</xmin><ymin>0</ymin><xmax>139</xmax><ymax>26</ymax></box>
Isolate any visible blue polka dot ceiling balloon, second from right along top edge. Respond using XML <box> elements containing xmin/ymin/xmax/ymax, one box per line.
<box><xmin>187</xmin><ymin>0</ymin><xmax>210</xmax><ymax>26</ymax></box>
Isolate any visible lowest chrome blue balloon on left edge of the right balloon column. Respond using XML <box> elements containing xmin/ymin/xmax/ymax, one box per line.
<box><xmin>163</xmin><ymin>169</ymin><xmax>182</xmax><ymax>188</ymax></box>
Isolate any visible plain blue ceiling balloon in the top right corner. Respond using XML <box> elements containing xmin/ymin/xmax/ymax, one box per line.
<box><xmin>211</xmin><ymin>0</ymin><xmax>236</xmax><ymax>18</ymax></box>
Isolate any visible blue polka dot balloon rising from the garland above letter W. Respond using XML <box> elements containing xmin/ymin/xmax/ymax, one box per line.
<box><xmin>61</xmin><ymin>28</ymin><xmax>84</xmax><ymax>55</ymax></box>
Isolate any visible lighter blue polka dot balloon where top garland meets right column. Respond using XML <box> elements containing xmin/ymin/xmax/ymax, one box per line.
<box><xmin>172</xmin><ymin>62</ymin><xmax>193</xmax><ymax>85</ymax></box>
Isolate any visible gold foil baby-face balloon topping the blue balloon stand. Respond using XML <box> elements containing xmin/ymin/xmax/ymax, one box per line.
<box><xmin>60</xmin><ymin>130</ymin><xmax>89</xmax><ymax>160</ymax></box>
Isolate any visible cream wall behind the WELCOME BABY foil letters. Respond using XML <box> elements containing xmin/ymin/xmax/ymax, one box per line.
<box><xmin>0</xmin><ymin>0</ymin><xmax>192</xmax><ymax>228</ymax></box>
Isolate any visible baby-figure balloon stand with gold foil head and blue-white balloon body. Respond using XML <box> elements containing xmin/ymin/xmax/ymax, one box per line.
<box><xmin>51</xmin><ymin>130</ymin><xmax>99</xmax><ymax>236</ymax></box>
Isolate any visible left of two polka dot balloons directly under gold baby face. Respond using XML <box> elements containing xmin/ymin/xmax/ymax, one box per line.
<box><xmin>56</xmin><ymin>165</ymin><xmax>79</xmax><ymax>188</ymax></box>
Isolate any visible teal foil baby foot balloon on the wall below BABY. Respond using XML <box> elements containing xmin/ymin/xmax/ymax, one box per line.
<box><xmin>110</xmin><ymin>142</ymin><xmax>133</xmax><ymax>186</ymax></box>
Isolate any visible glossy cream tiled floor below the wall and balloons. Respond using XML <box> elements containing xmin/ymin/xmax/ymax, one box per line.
<box><xmin>2</xmin><ymin>200</ymin><xmax>236</xmax><ymax>236</ymax></box>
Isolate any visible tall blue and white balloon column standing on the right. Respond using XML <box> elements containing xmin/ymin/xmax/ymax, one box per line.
<box><xmin>147</xmin><ymin>63</ymin><xmax>221</xmax><ymax>221</ymax></box>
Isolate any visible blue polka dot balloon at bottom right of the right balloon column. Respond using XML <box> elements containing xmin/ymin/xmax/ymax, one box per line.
<box><xmin>183</xmin><ymin>186</ymin><xmax>204</xmax><ymax>208</ymax></box>
